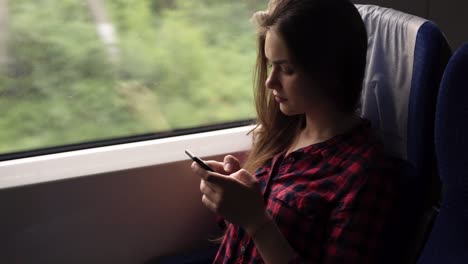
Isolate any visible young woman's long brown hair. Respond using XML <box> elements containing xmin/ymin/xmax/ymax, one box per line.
<box><xmin>244</xmin><ymin>0</ymin><xmax>367</xmax><ymax>172</ymax></box>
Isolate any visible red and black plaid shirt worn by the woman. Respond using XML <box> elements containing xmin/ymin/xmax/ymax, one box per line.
<box><xmin>214</xmin><ymin>121</ymin><xmax>396</xmax><ymax>264</ymax></box>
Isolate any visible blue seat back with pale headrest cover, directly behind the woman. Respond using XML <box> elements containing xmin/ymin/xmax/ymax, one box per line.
<box><xmin>356</xmin><ymin>5</ymin><xmax>451</xmax><ymax>263</ymax></box>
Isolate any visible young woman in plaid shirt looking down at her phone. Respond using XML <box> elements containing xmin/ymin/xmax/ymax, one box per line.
<box><xmin>192</xmin><ymin>0</ymin><xmax>395</xmax><ymax>264</ymax></box>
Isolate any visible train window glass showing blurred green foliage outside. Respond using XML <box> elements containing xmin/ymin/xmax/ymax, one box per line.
<box><xmin>0</xmin><ymin>0</ymin><xmax>266</xmax><ymax>159</ymax></box>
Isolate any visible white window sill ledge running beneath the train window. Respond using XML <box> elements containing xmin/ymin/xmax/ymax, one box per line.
<box><xmin>0</xmin><ymin>126</ymin><xmax>253</xmax><ymax>189</ymax></box>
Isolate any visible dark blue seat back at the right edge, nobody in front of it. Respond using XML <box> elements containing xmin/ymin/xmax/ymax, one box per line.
<box><xmin>418</xmin><ymin>43</ymin><xmax>468</xmax><ymax>264</ymax></box>
